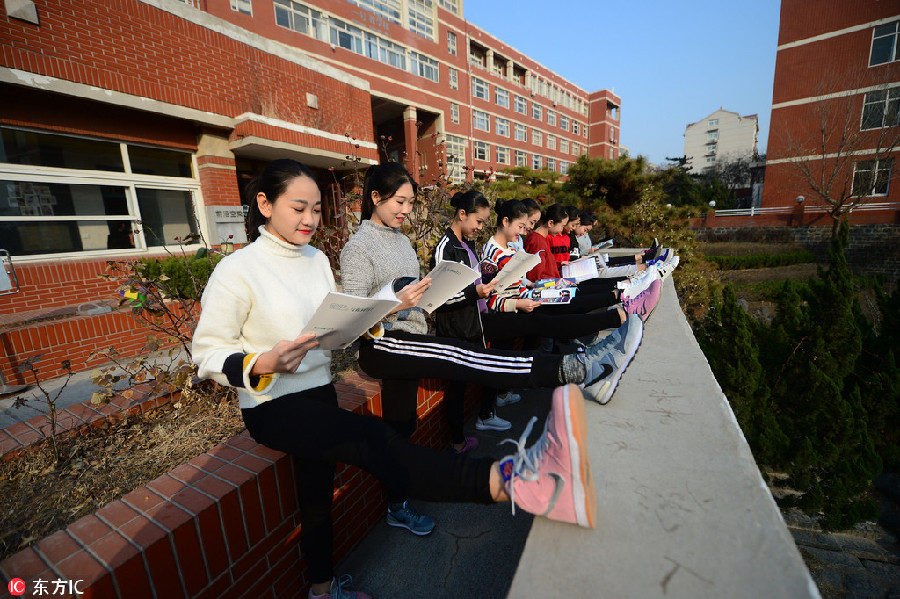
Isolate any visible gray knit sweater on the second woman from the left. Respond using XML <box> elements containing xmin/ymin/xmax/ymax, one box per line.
<box><xmin>341</xmin><ymin>220</ymin><xmax>428</xmax><ymax>335</ymax></box>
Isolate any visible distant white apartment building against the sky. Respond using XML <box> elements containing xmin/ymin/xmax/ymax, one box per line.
<box><xmin>684</xmin><ymin>107</ymin><xmax>759</xmax><ymax>173</ymax></box>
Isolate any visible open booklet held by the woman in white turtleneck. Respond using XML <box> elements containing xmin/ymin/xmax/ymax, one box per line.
<box><xmin>300</xmin><ymin>284</ymin><xmax>400</xmax><ymax>349</ymax></box>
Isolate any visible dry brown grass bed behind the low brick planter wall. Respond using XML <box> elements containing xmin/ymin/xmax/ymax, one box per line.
<box><xmin>0</xmin><ymin>388</ymin><xmax>244</xmax><ymax>560</ymax></box>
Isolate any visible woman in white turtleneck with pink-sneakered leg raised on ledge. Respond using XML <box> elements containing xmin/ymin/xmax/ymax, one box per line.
<box><xmin>193</xmin><ymin>160</ymin><xmax>596</xmax><ymax>599</ymax></box>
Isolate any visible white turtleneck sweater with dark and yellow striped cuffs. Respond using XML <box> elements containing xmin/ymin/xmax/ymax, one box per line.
<box><xmin>192</xmin><ymin>227</ymin><xmax>335</xmax><ymax>408</ymax></box>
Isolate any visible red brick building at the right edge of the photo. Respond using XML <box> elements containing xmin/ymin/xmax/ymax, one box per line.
<box><xmin>762</xmin><ymin>0</ymin><xmax>900</xmax><ymax>223</ymax></box>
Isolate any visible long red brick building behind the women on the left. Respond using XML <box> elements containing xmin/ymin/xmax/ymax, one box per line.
<box><xmin>0</xmin><ymin>0</ymin><xmax>621</xmax><ymax>382</ymax></box>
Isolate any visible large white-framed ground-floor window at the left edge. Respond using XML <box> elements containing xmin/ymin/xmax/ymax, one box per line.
<box><xmin>0</xmin><ymin>128</ymin><xmax>200</xmax><ymax>256</ymax></box>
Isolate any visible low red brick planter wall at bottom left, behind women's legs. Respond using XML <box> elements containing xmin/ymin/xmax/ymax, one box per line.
<box><xmin>0</xmin><ymin>375</ymin><xmax>475</xmax><ymax>599</ymax></box>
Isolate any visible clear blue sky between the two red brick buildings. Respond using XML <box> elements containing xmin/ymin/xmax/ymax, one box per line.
<box><xmin>463</xmin><ymin>0</ymin><xmax>780</xmax><ymax>164</ymax></box>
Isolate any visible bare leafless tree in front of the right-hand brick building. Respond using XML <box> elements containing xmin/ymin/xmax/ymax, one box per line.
<box><xmin>786</xmin><ymin>69</ymin><xmax>900</xmax><ymax>238</ymax></box>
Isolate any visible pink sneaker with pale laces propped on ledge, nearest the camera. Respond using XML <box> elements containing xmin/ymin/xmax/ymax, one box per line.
<box><xmin>500</xmin><ymin>385</ymin><xmax>597</xmax><ymax>528</ymax></box>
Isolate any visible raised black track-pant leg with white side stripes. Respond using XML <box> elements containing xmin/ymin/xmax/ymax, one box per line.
<box><xmin>359</xmin><ymin>331</ymin><xmax>563</xmax><ymax>389</ymax></box>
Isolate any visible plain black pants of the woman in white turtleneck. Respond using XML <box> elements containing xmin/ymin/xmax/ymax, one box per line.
<box><xmin>241</xmin><ymin>384</ymin><xmax>493</xmax><ymax>583</ymax></box>
